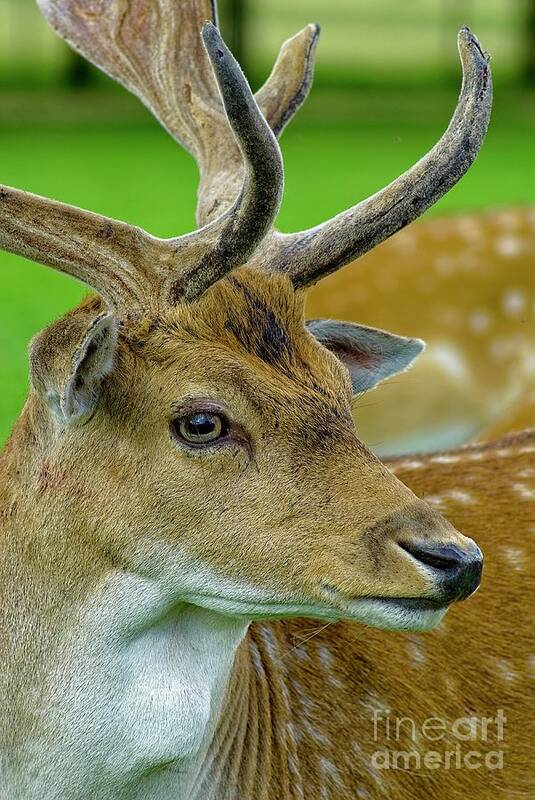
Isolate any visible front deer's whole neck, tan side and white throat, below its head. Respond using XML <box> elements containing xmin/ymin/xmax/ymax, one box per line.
<box><xmin>0</xmin><ymin>418</ymin><xmax>294</xmax><ymax>800</ymax></box>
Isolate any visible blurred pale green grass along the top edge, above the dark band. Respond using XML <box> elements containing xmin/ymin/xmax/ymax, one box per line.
<box><xmin>0</xmin><ymin>0</ymin><xmax>528</xmax><ymax>85</ymax></box>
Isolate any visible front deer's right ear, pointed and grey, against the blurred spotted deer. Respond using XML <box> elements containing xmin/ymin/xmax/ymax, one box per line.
<box><xmin>307</xmin><ymin>319</ymin><xmax>425</xmax><ymax>394</ymax></box>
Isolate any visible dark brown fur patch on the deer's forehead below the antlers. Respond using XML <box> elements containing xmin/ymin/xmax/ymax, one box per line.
<box><xmin>225</xmin><ymin>278</ymin><xmax>295</xmax><ymax>366</ymax></box>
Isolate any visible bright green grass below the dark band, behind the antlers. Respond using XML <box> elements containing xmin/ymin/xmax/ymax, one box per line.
<box><xmin>0</xmin><ymin>92</ymin><xmax>534</xmax><ymax>440</ymax></box>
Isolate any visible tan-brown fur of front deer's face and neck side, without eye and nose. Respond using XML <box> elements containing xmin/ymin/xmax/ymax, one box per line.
<box><xmin>0</xmin><ymin>269</ymin><xmax>480</xmax><ymax>788</ymax></box>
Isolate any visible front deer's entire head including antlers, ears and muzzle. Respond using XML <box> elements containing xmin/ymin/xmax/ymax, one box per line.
<box><xmin>0</xmin><ymin>0</ymin><xmax>491</xmax><ymax>628</ymax></box>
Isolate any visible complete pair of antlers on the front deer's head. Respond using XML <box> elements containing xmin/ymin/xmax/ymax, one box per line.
<box><xmin>0</xmin><ymin>0</ymin><xmax>492</xmax><ymax>314</ymax></box>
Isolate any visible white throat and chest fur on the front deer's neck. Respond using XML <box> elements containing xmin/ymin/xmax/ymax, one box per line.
<box><xmin>0</xmin><ymin>544</ymin><xmax>252</xmax><ymax>800</ymax></box>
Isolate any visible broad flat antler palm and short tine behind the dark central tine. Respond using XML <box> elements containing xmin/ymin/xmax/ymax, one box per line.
<box><xmin>37</xmin><ymin>0</ymin><xmax>318</xmax><ymax>225</ymax></box>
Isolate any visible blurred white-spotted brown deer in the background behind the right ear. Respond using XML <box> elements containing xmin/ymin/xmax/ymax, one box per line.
<box><xmin>307</xmin><ymin>206</ymin><xmax>535</xmax><ymax>455</ymax></box>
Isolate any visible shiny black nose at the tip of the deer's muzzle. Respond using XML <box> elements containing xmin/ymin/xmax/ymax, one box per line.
<box><xmin>400</xmin><ymin>542</ymin><xmax>483</xmax><ymax>603</ymax></box>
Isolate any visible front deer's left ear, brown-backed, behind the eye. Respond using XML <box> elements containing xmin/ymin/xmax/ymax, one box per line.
<box><xmin>30</xmin><ymin>313</ymin><xmax>118</xmax><ymax>424</ymax></box>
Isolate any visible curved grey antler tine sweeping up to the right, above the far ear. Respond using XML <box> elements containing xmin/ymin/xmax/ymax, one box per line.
<box><xmin>255</xmin><ymin>28</ymin><xmax>492</xmax><ymax>286</ymax></box>
